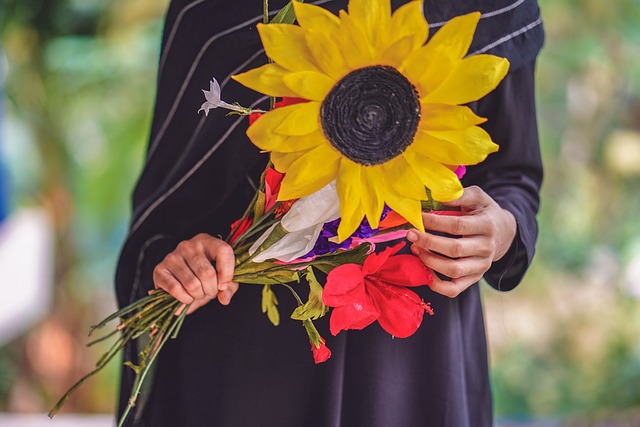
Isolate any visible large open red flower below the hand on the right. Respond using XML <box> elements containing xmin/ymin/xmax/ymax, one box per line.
<box><xmin>322</xmin><ymin>243</ymin><xmax>433</xmax><ymax>338</ymax></box>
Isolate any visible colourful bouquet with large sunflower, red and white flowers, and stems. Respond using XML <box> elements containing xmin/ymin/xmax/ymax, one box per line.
<box><xmin>50</xmin><ymin>0</ymin><xmax>509</xmax><ymax>424</ymax></box>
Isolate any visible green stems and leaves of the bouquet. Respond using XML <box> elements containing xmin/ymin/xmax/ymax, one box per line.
<box><xmin>49</xmin><ymin>0</ymin><xmax>312</xmax><ymax>427</ymax></box>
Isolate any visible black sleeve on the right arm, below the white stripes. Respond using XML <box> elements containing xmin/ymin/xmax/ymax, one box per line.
<box><xmin>463</xmin><ymin>61</ymin><xmax>542</xmax><ymax>291</ymax></box>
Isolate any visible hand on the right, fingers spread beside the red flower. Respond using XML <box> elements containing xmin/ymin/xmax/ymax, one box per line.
<box><xmin>407</xmin><ymin>186</ymin><xmax>516</xmax><ymax>298</ymax></box>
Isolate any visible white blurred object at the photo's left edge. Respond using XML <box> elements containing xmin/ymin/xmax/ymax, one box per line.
<box><xmin>0</xmin><ymin>209</ymin><xmax>53</xmax><ymax>345</ymax></box>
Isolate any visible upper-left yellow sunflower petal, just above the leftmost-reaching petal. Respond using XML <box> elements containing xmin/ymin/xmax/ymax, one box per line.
<box><xmin>257</xmin><ymin>24</ymin><xmax>319</xmax><ymax>71</ymax></box>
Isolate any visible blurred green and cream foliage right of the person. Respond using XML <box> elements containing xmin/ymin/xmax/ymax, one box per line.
<box><xmin>485</xmin><ymin>0</ymin><xmax>640</xmax><ymax>426</ymax></box>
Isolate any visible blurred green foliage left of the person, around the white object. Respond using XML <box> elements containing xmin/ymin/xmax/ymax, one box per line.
<box><xmin>0</xmin><ymin>0</ymin><xmax>168</xmax><ymax>412</ymax></box>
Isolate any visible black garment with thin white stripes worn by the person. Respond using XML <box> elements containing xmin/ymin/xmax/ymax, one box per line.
<box><xmin>116</xmin><ymin>0</ymin><xmax>543</xmax><ymax>427</ymax></box>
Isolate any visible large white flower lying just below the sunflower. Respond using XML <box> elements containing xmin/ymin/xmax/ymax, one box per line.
<box><xmin>249</xmin><ymin>181</ymin><xmax>340</xmax><ymax>262</ymax></box>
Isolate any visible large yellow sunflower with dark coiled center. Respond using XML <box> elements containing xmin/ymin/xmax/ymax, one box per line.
<box><xmin>233</xmin><ymin>0</ymin><xmax>509</xmax><ymax>241</ymax></box>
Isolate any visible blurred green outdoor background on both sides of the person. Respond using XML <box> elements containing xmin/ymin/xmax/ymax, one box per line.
<box><xmin>0</xmin><ymin>0</ymin><xmax>640</xmax><ymax>426</ymax></box>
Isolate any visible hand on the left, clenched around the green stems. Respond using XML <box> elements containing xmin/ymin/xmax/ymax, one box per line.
<box><xmin>153</xmin><ymin>234</ymin><xmax>238</xmax><ymax>314</ymax></box>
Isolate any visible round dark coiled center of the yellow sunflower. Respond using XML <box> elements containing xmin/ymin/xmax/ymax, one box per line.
<box><xmin>320</xmin><ymin>65</ymin><xmax>420</xmax><ymax>165</ymax></box>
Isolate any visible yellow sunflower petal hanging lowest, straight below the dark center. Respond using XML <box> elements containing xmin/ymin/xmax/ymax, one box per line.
<box><xmin>336</xmin><ymin>157</ymin><xmax>364</xmax><ymax>242</ymax></box>
